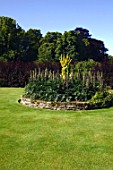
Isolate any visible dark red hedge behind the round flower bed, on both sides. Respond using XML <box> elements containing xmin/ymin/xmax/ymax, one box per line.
<box><xmin>0</xmin><ymin>60</ymin><xmax>113</xmax><ymax>88</ymax></box>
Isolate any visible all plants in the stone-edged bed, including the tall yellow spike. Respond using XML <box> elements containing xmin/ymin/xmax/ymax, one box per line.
<box><xmin>24</xmin><ymin>55</ymin><xmax>113</xmax><ymax>108</ymax></box>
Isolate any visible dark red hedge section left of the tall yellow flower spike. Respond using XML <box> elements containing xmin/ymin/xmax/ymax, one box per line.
<box><xmin>0</xmin><ymin>60</ymin><xmax>60</xmax><ymax>87</ymax></box>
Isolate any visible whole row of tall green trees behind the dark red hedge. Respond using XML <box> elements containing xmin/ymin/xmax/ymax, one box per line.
<box><xmin>0</xmin><ymin>16</ymin><xmax>108</xmax><ymax>62</ymax></box>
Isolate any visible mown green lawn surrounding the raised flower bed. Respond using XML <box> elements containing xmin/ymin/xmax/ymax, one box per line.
<box><xmin>0</xmin><ymin>88</ymin><xmax>113</xmax><ymax>170</ymax></box>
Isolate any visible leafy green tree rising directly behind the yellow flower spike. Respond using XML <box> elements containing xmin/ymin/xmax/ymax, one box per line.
<box><xmin>56</xmin><ymin>28</ymin><xmax>90</xmax><ymax>61</ymax></box>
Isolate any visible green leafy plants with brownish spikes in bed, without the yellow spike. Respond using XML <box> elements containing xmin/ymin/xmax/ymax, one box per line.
<box><xmin>24</xmin><ymin>67</ymin><xmax>102</xmax><ymax>102</ymax></box>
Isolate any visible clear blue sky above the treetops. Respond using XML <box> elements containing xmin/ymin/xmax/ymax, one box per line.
<box><xmin>0</xmin><ymin>0</ymin><xmax>113</xmax><ymax>56</ymax></box>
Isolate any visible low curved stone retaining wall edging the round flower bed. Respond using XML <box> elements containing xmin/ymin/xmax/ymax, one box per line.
<box><xmin>19</xmin><ymin>97</ymin><xmax>92</xmax><ymax>110</ymax></box>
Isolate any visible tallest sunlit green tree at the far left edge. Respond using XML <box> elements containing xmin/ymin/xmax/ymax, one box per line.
<box><xmin>0</xmin><ymin>16</ymin><xmax>24</xmax><ymax>61</ymax></box>
